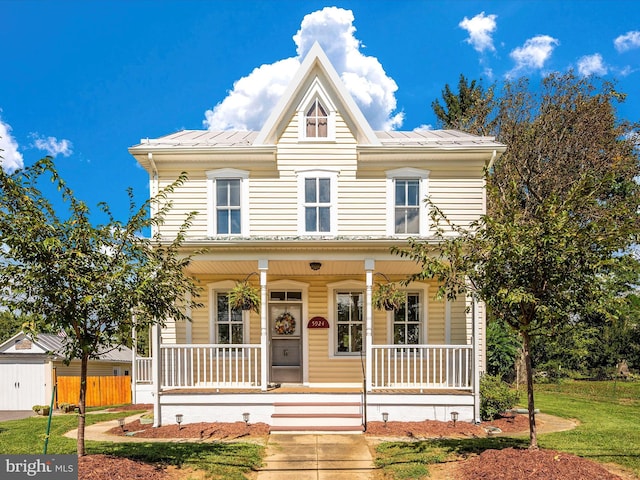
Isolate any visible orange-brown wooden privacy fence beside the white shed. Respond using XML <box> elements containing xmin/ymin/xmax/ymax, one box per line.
<box><xmin>57</xmin><ymin>375</ymin><xmax>131</xmax><ymax>407</ymax></box>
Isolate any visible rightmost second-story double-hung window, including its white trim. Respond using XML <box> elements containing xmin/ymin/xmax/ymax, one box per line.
<box><xmin>387</xmin><ymin>168</ymin><xmax>429</xmax><ymax>236</ymax></box>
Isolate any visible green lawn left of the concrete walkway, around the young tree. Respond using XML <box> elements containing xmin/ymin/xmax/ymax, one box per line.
<box><xmin>0</xmin><ymin>412</ymin><xmax>263</xmax><ymax>480</ymax></box>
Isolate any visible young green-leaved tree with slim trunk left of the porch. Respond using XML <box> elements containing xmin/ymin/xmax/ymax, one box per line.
<box><xmin>0</xmin><ymin>157</ymin><xmax>198</xmax><ymax>456</ymax></box>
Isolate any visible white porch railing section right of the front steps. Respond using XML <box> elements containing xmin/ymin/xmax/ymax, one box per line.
<box><xmin>371</xmin><ymin>345</ymin><xmax>473</xmax><ymax>390</ymax></box>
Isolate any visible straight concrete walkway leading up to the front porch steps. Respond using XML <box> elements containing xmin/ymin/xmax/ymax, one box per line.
<box><xmin>257</xmin><ymin>434</ymin><xmax>374</xmax><ymax>480</ymax></box>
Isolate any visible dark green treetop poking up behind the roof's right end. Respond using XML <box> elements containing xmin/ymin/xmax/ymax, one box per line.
<box><xmin>431</xmin><ymin>74</ymin><xmax>496</xmax><ymax>135</ymax></box>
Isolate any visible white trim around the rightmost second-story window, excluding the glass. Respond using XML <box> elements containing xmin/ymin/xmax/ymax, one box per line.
<box><xmin>386</xmin><ymin>167</ymin><xmax>430</xmax><ymax>238</ymax></box>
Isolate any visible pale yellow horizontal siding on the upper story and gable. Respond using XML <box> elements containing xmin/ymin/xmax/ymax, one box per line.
<box><xmin>159</xmin><ymin>107</ymin><xmax>484</xmax><ymax>238</ymax></box>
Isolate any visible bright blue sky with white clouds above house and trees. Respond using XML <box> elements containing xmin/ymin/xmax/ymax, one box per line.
<box><xmin>0</xmin><ymin>0</ymin><xmax>640</xmax><ymax>219</ymax></box>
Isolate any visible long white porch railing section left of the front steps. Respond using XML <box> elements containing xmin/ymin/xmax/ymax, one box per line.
<box><xmin>160</xmin><ymin>344</ymin><xmax>261</xmax><ymax>388</ymax></box>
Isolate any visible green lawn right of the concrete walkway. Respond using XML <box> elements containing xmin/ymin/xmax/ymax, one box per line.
<box><xmin>376</xmin><ymin>381</ymin><xmax>640</xmax><ymax>479</ymax></box>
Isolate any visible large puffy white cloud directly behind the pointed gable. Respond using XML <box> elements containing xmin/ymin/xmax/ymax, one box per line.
<box><xmin>203</xmin><ymin>7</ymin><xmax>404</xmax><ymax>130</ymax></box>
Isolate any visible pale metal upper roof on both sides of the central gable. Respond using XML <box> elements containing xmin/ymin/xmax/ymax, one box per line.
<box><xmin>133</xmin><ymin>130</ymin><xmax>504</xmax><ymax>148</ymax></box>
